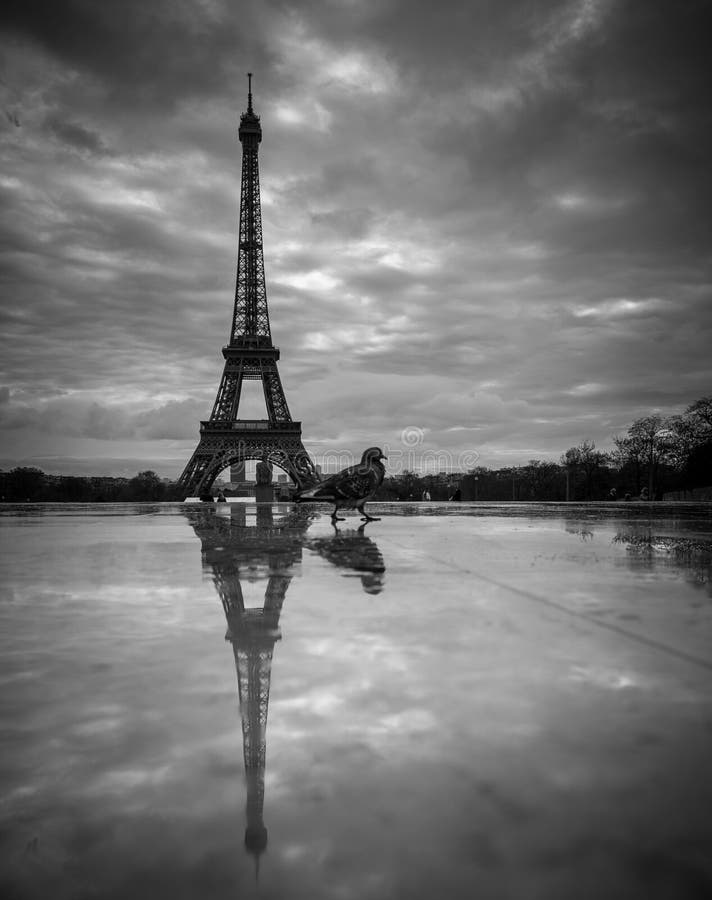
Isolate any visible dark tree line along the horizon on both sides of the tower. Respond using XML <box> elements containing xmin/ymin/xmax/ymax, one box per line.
<box><xmin>0</xmin><ymin>397</ymin><xmax>712</xmax><ymax>503</ymax></box>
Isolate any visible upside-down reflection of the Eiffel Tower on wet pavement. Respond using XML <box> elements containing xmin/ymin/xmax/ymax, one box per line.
<box><xmin>184</xmin><ymin>503</ymin><xmax>310</xmax><ymax>863</ymax></box>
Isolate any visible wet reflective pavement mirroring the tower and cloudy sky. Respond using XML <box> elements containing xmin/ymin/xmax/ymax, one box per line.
<box><xmin>0</xmin><ymin>503</ymin><xmax>712</xmax><ymax>900</ymax></box>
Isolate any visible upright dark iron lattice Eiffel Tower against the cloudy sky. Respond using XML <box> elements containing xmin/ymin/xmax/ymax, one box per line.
<box><xmin>178</xmin><ymin>72</ymin><xmax>319</xmax><ymax>497</ymax></box>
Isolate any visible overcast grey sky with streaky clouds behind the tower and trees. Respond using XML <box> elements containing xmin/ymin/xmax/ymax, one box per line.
<box><xmin>0</xmin><ymin>0</ymin><xmax>712</xmax><ymax>476</ymax></box>
